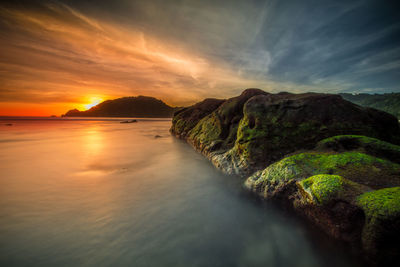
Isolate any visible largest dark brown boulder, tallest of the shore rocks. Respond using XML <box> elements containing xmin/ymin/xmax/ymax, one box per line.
<box><xmin>171</xmin><ymin>88</ymin><xmax>400</xmax><ymax>176</ymax></box>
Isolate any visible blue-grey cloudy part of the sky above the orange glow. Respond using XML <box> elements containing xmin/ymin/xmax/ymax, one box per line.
<box><xmin>61</xmin><ymin>0</ymin><xmax>400</xmax><ymax>91</ymax></box>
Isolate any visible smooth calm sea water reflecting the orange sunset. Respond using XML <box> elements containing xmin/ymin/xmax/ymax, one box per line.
<box><xmin>0</xmin><ymin>120</ymin><xmax>360</xmax><ymax>267</ymax></box>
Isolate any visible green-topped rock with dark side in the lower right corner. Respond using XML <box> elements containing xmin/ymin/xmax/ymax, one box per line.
<box><xmin>357</xmin><ymin>187</ymin><xmax>400</xmax><ymax>263</ymax></box>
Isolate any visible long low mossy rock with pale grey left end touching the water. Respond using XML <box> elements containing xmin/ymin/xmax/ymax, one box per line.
<box><xmin>245</xmin><ymin>152</ymin><xmax>400</xmax><ymax>198</ymax></box>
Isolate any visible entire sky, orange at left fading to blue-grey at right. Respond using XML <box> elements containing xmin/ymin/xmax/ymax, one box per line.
<box><xmin>0</xmin><ymin>0</ymin><xmax>400</xmax><ymax>116</ymax></box>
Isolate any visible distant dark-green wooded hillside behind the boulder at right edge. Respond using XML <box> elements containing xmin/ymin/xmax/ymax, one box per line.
<box><xmin>340</xmin><ymin>93</ymin><xmax>400</xmax><ymax>120</ymax></box>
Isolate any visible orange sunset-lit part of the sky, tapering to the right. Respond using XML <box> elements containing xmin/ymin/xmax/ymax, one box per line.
<box><xmin>0</xmin><ymin>4</ymin><xmax>278</xmax><ymax>116</ymax></box>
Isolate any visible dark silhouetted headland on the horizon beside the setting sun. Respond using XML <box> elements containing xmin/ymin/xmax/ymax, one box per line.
<box><xmin>62</xmin><ymin>96</ymin><xmax>176</xmax><ymax>118</ymax></box>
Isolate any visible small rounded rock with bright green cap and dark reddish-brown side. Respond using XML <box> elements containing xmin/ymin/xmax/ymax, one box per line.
<box><xmin>290</xmin><ymin>174</ymin><xmax>371</xmax><ymax>244</ymax></box>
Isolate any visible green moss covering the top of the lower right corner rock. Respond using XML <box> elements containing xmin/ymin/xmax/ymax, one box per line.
<box><xmin>357</xmin><ymin>187</ymin><xmax>400</xmax><ymax>219</ymax></box>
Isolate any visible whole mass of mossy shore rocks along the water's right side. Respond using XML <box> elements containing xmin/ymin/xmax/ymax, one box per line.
<box><xmin>171</xmin><ymin>89</ymin><xmax>400</xmax><ymax>264</ymax></box>
